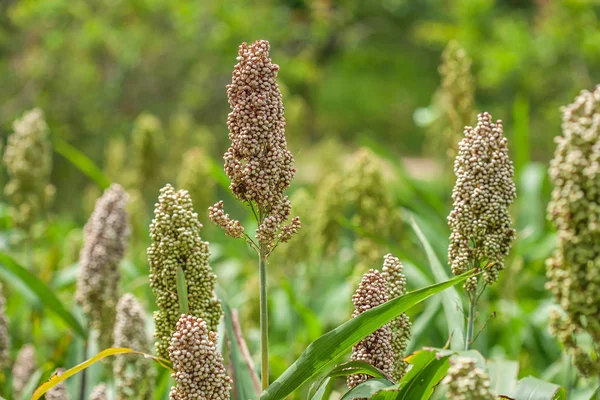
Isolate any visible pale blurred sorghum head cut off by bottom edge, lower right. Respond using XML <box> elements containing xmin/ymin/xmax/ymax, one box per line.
<box><xmin>442</xmin><ymin>357</ymin><xmax>496</xmax><ymax>400</ymax></box>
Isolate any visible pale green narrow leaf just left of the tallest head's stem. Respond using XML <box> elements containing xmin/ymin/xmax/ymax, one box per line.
<box><xmin>221</xmin><ymin>299</ymin><xmax>260</xmax><ymax>400</ymax></box>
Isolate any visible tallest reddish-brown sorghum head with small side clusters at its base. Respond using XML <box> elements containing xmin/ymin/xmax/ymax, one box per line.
<box><xmin>210</xmin><ymin>40</ymin><xmax>300</xmax><ymax>252</ymax></box>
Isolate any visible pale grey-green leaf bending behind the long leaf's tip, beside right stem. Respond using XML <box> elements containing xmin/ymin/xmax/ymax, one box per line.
<box><xmin>410</xmin><ymin>215</ymin><xmax>465</xmax><ymax>351</ymax></box>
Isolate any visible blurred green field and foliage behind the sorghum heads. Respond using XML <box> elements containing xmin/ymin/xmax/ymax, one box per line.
<box><xmin>0</xmin><ymin>0</ymin><xmax>600</xmax><ymax>398</ymax></box>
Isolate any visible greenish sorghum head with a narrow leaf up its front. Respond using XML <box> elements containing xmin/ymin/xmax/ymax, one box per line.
<box><xmin>148</xmin><ymin>185</ymin><xmax>222</xmax><ymax>358</ymax></box>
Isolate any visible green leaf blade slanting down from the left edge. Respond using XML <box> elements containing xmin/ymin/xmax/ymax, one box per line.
<box><xmin>0</xmin><ymin>253</ymin><xmax>88</xmax><ymax>339</ymax></box>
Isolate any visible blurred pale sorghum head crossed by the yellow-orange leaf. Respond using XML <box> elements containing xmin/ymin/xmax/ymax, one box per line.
<box><xmin>113</xmin><ymin>293</ymin><xmax>154</xmax><ymax>400</ymax></box>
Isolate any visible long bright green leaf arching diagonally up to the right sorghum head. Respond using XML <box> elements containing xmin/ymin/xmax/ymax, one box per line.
<box><xmin>261</xmin><ymin>271</ymin><xmax>472</xmax><ymax>400</ymax></box>
